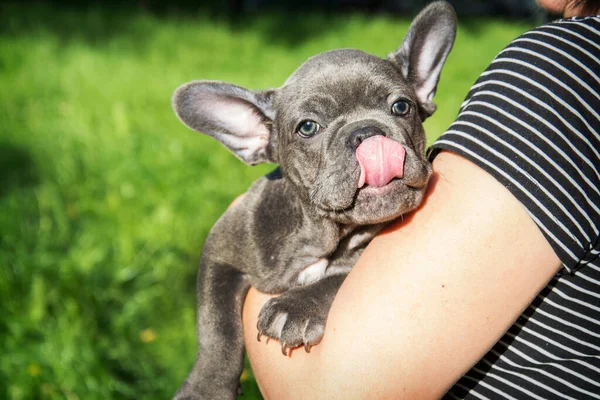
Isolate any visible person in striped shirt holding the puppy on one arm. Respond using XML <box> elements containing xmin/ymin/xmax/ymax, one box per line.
<box><xmin>244</xmin><ymin>0</ymin><xmax>600</xmax><ymax>399</ymax></box>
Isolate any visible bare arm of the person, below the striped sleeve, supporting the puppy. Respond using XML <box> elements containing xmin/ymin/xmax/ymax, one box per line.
<box><xmin>244</xmin><ymin>152</ymin><xmax>560</xmax><ymax>399</ymax></box>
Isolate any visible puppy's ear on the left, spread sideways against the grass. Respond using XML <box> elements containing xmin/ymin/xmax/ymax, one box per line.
<box><xmin>172</xmin><ymin>81</ymin><xmax>275</xmax><ymax>165</ymax></box>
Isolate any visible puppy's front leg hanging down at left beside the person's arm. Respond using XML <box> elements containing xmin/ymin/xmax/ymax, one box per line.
<box><xmin>174</xmin><ymin>259</ymin><xmax>250</xmax><ymax>400</ymax></box>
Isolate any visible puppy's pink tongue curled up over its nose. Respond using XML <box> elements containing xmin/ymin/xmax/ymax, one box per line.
<box><xmin>356</xmin><ymin>135</ymin><xmax>406</xmax><ymax>188</ymax></box>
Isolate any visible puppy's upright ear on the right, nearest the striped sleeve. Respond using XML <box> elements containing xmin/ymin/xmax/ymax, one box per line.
<box><xmin>388</xmin><ymin>1</ymin><xmax>456</xmax><ymax>120</ymax></box>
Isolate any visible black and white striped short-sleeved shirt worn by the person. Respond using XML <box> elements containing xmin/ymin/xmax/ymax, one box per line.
<box><xmin>430</xmin><ymin>17</ymin><xmax>600</xmax><ymax>399</ymax></box>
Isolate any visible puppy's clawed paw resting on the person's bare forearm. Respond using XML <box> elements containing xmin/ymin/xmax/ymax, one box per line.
<box><xmin>258</xmin><ymin>290</ymin><xmax>329</xmax><ymax>355</ymax></box>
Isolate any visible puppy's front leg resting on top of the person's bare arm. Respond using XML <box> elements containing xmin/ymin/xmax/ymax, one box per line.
<box><xmin>258</xmin><ymin>273</ymin><xmax>347</xmax><ymax>355</ymax></box>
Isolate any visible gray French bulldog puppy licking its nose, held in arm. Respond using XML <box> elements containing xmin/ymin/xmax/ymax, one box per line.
<box><xmin>173</xmin><ymin>2</ymin><xmax>456</xmax><ymax>399</ymax></box>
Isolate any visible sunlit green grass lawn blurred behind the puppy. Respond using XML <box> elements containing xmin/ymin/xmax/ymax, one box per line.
<box><xmin>0</xmin><ymin>4</ymin><xmax>528</xmax><ymax>400</ymax></box>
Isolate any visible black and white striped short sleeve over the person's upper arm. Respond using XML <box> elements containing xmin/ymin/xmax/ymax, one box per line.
<box><xmin>429</xmin><ymin>17</ymin><xmax>600</xmax><ymax>273</ymax></box>
